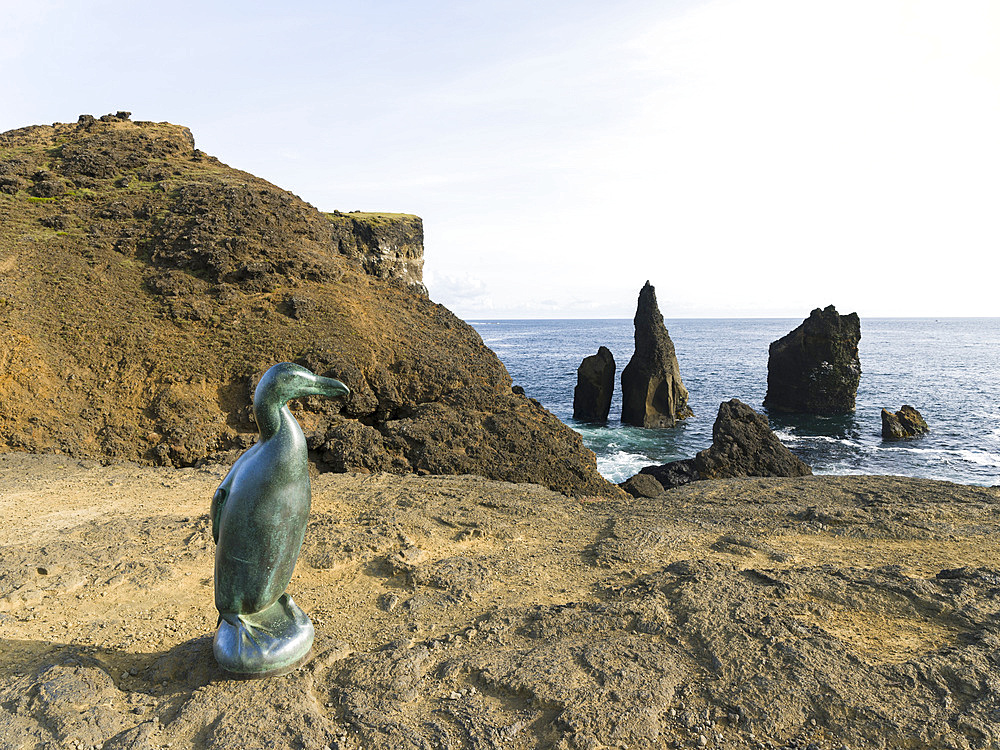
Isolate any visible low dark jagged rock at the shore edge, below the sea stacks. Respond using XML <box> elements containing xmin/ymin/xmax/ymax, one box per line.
<box><xmin>619</xmin><ymin>398</ymin><xmax>812</xmax><ymax>497</ymax></box>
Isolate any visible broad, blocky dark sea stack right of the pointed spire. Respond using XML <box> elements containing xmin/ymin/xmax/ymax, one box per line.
<box><xmin>764</xmin><ymin>305</ymin><xmax>861</xmax><ymax>415</ymax></box>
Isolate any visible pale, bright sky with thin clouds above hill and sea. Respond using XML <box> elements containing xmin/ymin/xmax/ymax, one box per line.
<box><xmin>0</xmin><ymin>0</ymin><xmax>1000</xmax><ymax>320</ymax></box>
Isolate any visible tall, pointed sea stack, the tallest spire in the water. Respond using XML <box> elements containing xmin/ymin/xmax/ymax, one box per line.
<box><xmin>622</xmin><ymin>281</ymin><xmax>692</xmax><ymax>427</ymax></box>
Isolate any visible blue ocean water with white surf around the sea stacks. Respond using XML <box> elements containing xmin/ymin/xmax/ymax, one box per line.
<box><xmin>469</xmin><ymin>318</ymin><xmax>1000</xmax><ymax>485</ymax></box>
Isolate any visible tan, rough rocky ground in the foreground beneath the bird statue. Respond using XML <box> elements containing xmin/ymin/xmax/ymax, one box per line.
<box><xmin>0</xmin><ymin>453</ymin><xmax>1000</xmax><ymax>750</ymax></box>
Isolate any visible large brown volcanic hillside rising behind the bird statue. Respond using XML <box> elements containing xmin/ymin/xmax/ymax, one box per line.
<box><xmin>0</xmin><ymin>113</ymin><xmax>620</xmax><ymax>496</ymax></box>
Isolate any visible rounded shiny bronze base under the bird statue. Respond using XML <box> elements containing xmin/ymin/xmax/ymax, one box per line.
<box><xmin>212</xmin><ymin>594</ymin><xmax>315</xmax><ymax>678</ymax></box>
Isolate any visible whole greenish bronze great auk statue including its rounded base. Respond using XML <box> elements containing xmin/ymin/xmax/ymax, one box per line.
<box><xmin>211</xmin><ymin>362</ymin><xmax>349</xmax><ymax>676</ymax></box>
